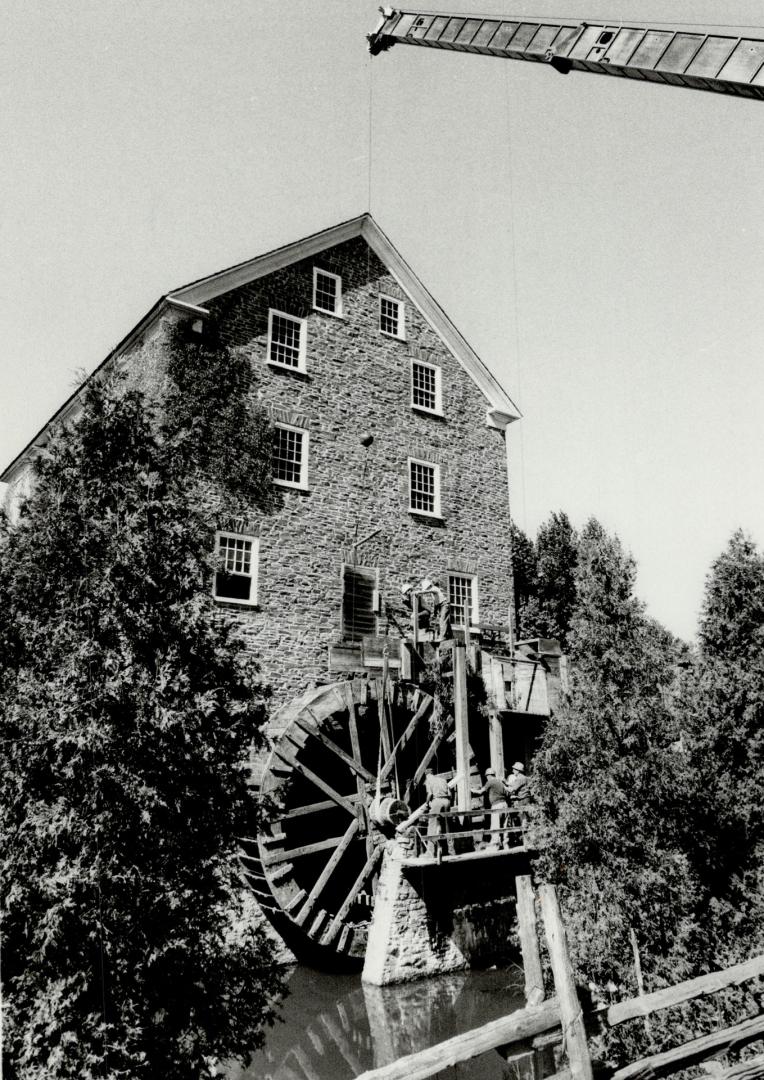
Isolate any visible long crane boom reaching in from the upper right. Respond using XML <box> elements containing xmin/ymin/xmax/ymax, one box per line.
<box><xmin>368</xmin><ymin>8</ymin><xmax>764</xmax><ymax>100</ymax></box>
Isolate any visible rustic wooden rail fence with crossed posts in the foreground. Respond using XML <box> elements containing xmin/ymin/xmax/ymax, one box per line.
<box><xmin>358</xmin><ymin>876</ymin><xmax>764</xmax><ymax>1080</ymax></box>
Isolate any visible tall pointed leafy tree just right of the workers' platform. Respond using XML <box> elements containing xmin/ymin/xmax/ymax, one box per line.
<box><xmin>534</xmin><ymin>519</ymin><xmax>700</xmax><ymax>1055</ymax></box>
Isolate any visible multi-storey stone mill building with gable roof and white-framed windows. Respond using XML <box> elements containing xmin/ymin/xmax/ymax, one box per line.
<box><xmin>0</xmin><ymin>215</ymin><xmax>518</xmax><ymax>704</ymax></box>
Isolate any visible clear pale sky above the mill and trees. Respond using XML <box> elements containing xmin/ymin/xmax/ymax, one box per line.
<box><xmin>0</xmin><ymin>0</ymin><xmax>764</xmax><ymax>636</ymax></box>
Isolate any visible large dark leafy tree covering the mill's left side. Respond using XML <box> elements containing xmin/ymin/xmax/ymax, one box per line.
<box><xmin>0</xmin><ymin>352</ymin><xmax>279</xmax><ymax>1080</ymax></box>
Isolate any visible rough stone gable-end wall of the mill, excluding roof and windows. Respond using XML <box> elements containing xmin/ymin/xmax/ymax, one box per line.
<box><xmin>202</xmin><ymin>238</ymin><xmax>511</xmax><ymax>705</ymax></box>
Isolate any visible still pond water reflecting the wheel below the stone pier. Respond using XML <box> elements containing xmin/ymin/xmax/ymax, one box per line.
<box><xmin>227</xmin><ymin>967</ymin><xmax>525</xmax><ymax>1080</ymax></box>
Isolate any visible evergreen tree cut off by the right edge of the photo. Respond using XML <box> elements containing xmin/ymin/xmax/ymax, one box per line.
<box><xmin>685</xmin><ymin>531</ymin><xmax>764</xmax><ymax>964</ymax></box>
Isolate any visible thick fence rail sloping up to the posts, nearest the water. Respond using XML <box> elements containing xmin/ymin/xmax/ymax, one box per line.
<box><xmin>358</xmin><ymin>998</ymin><xmax>560</xmax><ymax>1080</ymax></box>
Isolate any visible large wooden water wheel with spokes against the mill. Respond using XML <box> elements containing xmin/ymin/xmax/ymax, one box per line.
<box><xmin>241</xmin><ymin>678</ymin><xmax>453</xmax><ymax>962</ymax></box>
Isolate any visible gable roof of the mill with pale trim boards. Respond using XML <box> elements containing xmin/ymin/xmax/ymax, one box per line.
<box><xmin>0</xmin><ymin>214</ymin><xmax>521</xmax><ymax>483</ymax></box>
